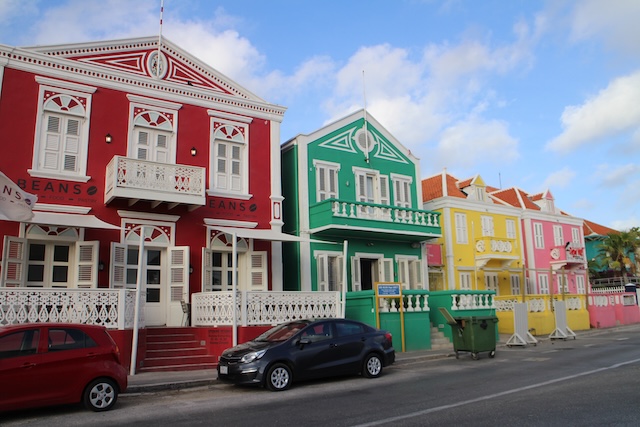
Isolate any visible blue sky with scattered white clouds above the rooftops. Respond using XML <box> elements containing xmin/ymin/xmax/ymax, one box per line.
<box><xmin>0</xmin><ymin>0</ymin><xmax>640</xmax><ymax>230</ymax></box>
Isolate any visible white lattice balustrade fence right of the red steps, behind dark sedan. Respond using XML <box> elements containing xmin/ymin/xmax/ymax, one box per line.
<box><xmin>191</xmin><ymin>291</ymin><xmax>341</xmax><ymax>326</ymax></box>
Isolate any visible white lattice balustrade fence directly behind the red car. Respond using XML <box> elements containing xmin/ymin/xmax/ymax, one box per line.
<box><xmin>0</xmin><ymin>288</ymin><xmax>145</xmax><ymax>329</ymax></box>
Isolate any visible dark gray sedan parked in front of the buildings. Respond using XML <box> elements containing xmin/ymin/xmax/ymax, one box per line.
<box><xmin>218</xmin><ymin>319</ymin><xmax>395</xmax><ymax>391</ymax></box>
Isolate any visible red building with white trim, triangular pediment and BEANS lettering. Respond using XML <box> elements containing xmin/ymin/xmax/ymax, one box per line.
<box><xmin>0</xmin><ymin>37</ymin><xmax>285</xmax><ymax>334</ymax></box>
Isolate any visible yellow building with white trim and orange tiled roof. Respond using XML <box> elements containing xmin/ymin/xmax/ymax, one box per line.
<box><xmin>422</xmin><ymin>171</ymin><xmax>524</xmax><ymax>296</ymax></box>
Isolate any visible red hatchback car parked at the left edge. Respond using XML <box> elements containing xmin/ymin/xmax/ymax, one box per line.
<box><xmin>0</xmin><ymin>323</ymin><xmax>127</xmax><ymax>411</ymax></box>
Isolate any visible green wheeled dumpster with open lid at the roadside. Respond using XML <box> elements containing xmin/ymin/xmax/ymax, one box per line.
<box><xmin>441</xmin><ymin>309</ymin><xmax>498</xmax><ymax>360</ymax></box>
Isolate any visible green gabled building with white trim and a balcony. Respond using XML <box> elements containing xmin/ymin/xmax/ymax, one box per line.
<box><xmin>282</xmin><ymin>110</ymin><xmax>441</xmax><ymax>292</ymax></box>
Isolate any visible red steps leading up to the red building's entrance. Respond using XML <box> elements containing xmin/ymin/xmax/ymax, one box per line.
<box><xmin>139</xmin><ymin>328</ymin><xmax>217</xmax><ymax>372</ymax></box>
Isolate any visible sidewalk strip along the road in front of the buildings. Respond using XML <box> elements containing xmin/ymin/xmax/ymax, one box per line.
<box><xmin>123</xmin><ymin>325</ymin><xmax>640</xmax><ymax>395</ymax></box>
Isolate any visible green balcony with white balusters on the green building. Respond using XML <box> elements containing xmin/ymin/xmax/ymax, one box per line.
<box><xmin>309</xmin><ymin>199</ymin><xmax>441</xmax><ymax>242</ymax></box>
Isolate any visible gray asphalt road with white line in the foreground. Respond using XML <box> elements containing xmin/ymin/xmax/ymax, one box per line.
<box><xmin>5</xmin><ymin>327</ymin><xmax>640</xmax><ymax>427</ymax></box>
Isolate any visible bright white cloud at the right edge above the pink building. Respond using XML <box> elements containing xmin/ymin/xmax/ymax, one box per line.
<box><xmin>546</xmin><ymin>71</ymin><xmax>640</xmax><ymax>152</ymax></box>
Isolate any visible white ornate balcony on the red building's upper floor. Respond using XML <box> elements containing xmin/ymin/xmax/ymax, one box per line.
<box><xmin>104</xmin><ymin>156</ymin><xmax>206</xmax><ymax>210</ymax></box>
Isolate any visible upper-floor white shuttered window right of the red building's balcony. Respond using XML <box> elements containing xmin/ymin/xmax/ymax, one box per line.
<box><xmin>210</xmin><ymin>119</ymin><xmax>249</xmax><ymax>197</ymax></box>
